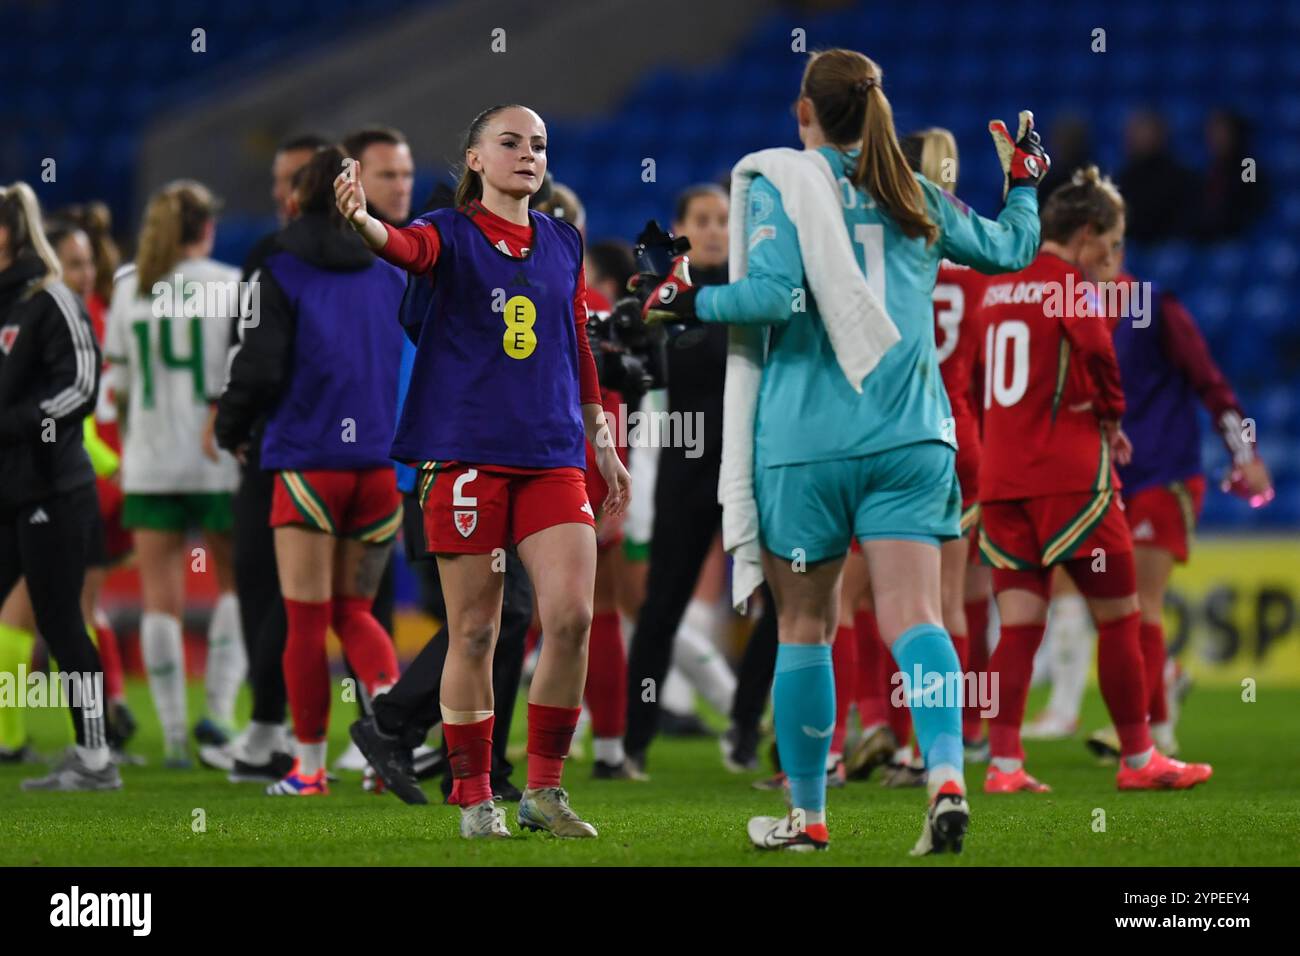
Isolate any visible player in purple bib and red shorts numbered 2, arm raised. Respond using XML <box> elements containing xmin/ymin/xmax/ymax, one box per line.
<box><xmin>335</xmin><ymin>105</ymin><xmax>631</xmax><ymax>838</ymax></box>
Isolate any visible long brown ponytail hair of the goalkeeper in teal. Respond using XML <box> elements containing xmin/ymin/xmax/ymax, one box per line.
<box><xmin>800</xmin><ymin>49</ymin><xmax>939</xmax><ymax>245</ymax></box>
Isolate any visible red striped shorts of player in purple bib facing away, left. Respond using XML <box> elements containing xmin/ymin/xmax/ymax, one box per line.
<box><xmin>270</xmin><ymin>468</ymin><xmax>402</xmax><ymax>545</ymax></box>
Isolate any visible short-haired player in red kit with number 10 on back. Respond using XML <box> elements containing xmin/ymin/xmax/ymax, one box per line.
<box><xmin>979</xmin><ymin>166</ymin><xmax>1210</xmax><ymax>793</ymax></box>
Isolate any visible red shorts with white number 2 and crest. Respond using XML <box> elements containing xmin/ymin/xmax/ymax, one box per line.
<box><xmin>420</xmin><ymin>464</ymin><xmax>595</xmax><ymax>554</ymax></box>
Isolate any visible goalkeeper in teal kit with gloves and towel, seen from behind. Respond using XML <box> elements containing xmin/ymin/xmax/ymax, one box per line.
<box><xmin>641</xmin><ymin>49</ymin><xmax>1048</xmax><ymax>855</ymax></box>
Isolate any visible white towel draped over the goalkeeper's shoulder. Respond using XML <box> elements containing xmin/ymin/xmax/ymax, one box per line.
<box><xmin>718</xmin><ymin>148</ymin><xmax>900</xmax><ymax>609</ymax></box>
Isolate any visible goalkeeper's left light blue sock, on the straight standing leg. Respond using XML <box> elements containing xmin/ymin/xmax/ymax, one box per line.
<box><xmin>772</xmin><ymin>644</ymin><xmax>835</xmax><ymax>813</ymax></box>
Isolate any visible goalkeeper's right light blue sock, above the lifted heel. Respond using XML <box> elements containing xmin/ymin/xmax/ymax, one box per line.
<box><xmin>892</xmin><ymin>624</ymin><xmax>963</xmax><ymax>779</ymax></box>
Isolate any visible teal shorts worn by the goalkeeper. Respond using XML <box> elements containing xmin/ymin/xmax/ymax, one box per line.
<box><xmin>754</xmin><ymin>441</ymin><xmax>962</xmax><ymax>563</ymax></box>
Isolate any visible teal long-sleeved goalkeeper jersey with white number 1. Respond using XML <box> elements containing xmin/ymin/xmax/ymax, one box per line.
<box><xmin>696</xmin><ymin>147</ymin><xmax>1039</xmax><ymax>467</ymax></box>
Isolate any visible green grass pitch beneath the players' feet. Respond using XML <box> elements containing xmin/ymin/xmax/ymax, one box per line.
<box><xmin>0</xmin><ymin>682</ymin><xmax>1300</xmax><ymax>866</ymax></box>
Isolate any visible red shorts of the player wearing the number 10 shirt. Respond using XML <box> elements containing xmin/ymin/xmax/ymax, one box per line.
<box><xmin>979</xmin><ymin>489</ymin><xmax>1134</xmax><ymax>571</ymax></box>
